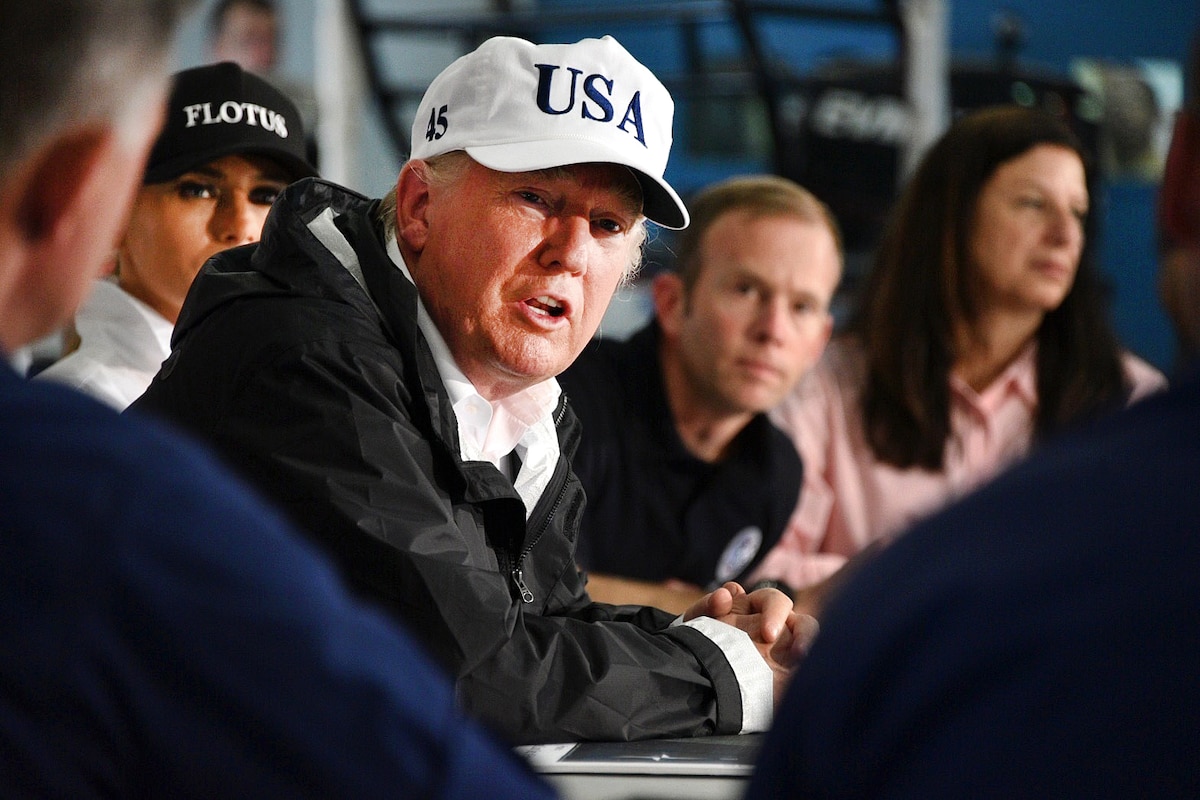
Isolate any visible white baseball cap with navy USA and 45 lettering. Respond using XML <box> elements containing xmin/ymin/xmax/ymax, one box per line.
<box><xmin>412</xmin><ymin>36</ymin><xmax>688</xmax><ymax>229</ymax></box>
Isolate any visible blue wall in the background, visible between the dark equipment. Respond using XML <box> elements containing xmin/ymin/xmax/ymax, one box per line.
<box><xmin>541</xmin><ymin>0</ymin><xmax>1200</xmax><ymax>371</ymax></box>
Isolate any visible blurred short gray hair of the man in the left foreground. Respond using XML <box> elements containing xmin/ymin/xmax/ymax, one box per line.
<box><xmin>0</xmin><ymin>0</ymin><xmax>194</xmax><ymax>174</ymax></box>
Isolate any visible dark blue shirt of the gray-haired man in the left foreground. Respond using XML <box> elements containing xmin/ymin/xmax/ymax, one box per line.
<box><xmin>0</xmin><ymin>368</ymin><xmax>552</xmax><ymax>800</ymax></box>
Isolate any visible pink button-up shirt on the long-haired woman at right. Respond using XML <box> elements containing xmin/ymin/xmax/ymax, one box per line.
<box><xmin>751</xmin><ymin>338</ymin><xmax>1166</xmax><ymax>588</ymax></box>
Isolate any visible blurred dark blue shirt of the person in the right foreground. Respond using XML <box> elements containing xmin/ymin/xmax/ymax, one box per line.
<box><xmin>748</xmin><ymin>367</ymin><xmax>1200</xmax><ymax>800</ymax></box>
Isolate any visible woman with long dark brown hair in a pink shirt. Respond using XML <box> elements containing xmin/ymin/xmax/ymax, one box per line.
<box><xmin>754</xmin><ymin>107</ymin><xmax>1165</xmax><ymax>589</ymax></box>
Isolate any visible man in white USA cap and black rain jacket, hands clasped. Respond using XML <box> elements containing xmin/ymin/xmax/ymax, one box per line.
<box><xmin>133</xmin><ymin>31</ymin><xmax>811</xmax><ymax>742</ymax></box>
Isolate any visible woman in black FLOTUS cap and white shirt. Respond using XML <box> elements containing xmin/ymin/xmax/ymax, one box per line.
<box><xmin>38</xmin><ymin>62</ymin><xmax>316</xmax><ymax>410</ymax></box>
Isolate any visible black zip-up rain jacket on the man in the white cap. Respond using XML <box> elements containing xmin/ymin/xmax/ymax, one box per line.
<box><xmin>132</xmin><ymin>179</ymin><xmax>742</xmax><ymax>742</ymax></box>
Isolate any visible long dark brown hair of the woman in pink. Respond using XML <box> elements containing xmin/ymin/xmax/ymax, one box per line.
<box><xmin>850</xmin><ymin>106</ymin><xmax>1128</xmax><ymax>469</ymax></box>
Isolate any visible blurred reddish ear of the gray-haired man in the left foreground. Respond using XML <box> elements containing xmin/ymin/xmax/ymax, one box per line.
<box><xmin>13</xmin><ymin>126</ymin><xmax>112</xmax><ymax>248</ymax></box>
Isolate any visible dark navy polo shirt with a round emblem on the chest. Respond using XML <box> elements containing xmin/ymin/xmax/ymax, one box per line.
<box><xmin>559</xmin><ymin>323</ymin><xmax>800</xmax><ymax>587</ymax></box>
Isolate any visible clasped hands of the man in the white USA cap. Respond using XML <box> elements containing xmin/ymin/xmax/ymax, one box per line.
<box><xmin>684</xmin><ymin>581</ymin><xmax>817</xmax><ymax>703</ymax></box>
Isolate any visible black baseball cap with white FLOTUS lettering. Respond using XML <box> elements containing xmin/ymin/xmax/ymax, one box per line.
<box><xmin>143</xmin><ymin>61</ymin><xmax>317</xmax><ymax>184</ymax></box>
